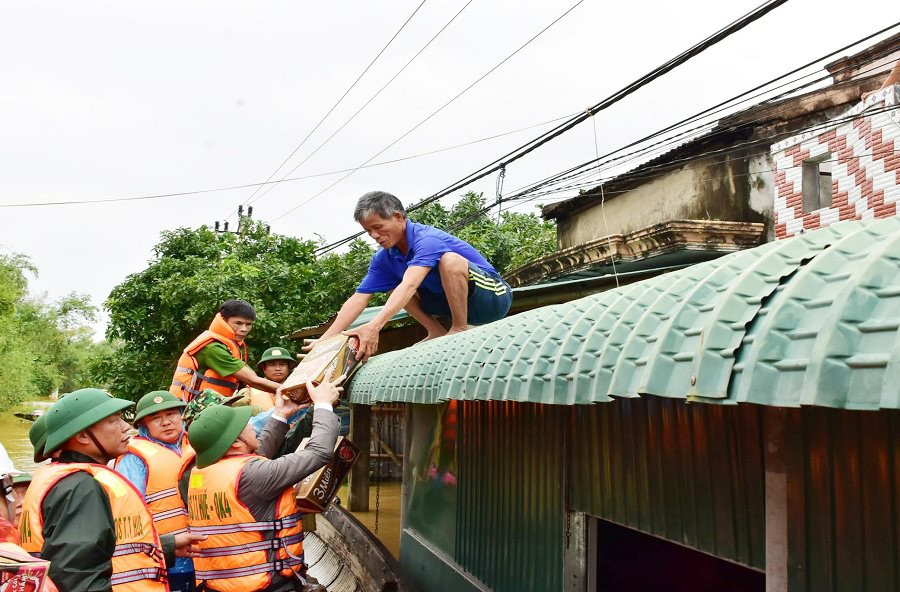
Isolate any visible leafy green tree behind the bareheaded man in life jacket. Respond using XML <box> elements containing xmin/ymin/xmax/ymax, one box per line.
<box><xmin>99</xmin><ymin>218</ymin><xmax>372</xmax><ymax>399</ymax></box>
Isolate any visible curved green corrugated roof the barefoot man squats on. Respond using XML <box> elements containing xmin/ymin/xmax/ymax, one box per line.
<box><xmin>351</xmin><ymin>217</ymin><xmax>900</xmax><ymax>409</ymax></box>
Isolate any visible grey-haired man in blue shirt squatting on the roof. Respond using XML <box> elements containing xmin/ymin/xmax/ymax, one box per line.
<box><xmin>322</xmin><ymin>191</ymin><xmax>512</xmax><ymax>360</ymax></box>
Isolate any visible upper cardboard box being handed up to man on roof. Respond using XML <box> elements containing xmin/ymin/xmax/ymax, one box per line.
<box><xmin>281</xmin><ymin>335</ymin><xmax>359</xmax><ymax>405</ymax></box>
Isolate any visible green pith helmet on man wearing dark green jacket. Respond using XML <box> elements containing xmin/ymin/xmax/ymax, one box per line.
<box><xmin>44</xmin><ymin>388</ymin><xmax>134</xmax><ymax>455</ymax></box>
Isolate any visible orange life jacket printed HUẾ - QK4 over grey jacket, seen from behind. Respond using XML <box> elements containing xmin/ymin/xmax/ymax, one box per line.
<box><xmin>188</xmin><ymin>455</ymin><xmax>303</xmax><ymax>592</ymax></box>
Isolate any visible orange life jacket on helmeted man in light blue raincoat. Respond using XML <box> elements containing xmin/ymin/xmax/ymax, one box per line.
<box><xmin>116</xmin><ymin>434</ymin><xmax>196</xmax><ymax>534</ymax></box>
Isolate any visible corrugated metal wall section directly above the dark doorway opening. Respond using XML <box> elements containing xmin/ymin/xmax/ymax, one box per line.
<box><xmin>571</xmin><ymin>396</ymin><xmax>765</xmax><ymax>569</ymax></box>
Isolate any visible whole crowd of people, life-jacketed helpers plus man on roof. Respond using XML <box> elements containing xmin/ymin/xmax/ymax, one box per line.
<box><xmin>0</xmin><ymin>192</ymin><xmax>512</xmax><ymax>592</ymax></box>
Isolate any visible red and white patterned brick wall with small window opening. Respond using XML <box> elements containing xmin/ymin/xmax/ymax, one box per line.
<box><xmin>771</xmin><ymin>85</ymin><xmax>900</xmax><ymax>238</ymax></box>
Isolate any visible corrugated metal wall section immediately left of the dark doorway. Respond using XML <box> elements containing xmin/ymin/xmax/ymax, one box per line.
<box><xmin>455</xmin><ymin>402</ymin><xmax>571</xmax><ymax>592</ymax></box>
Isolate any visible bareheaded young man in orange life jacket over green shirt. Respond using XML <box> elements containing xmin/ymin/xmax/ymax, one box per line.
<box><xmin>169</xmin><ymin>300</ymin><xmax>281</xmax><ymax>402</ymax></box>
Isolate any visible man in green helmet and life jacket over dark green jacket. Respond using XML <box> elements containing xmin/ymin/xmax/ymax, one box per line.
<box><xmin>19</xmin><ymin>388</ymin><xmax>204</xmax><ymax>592</ymax></box>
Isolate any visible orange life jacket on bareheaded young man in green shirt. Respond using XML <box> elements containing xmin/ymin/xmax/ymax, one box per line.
<box><xmin>169</xmin><ymin>313</ymin><xmax>247</xmax><ymax>401</ymax></box>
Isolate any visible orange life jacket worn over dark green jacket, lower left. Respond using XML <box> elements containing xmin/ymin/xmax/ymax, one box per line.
<box><xmin>19</xmin><ymin>463</ymin><xmax>169</xmax><ymax>592</ymax></box>
